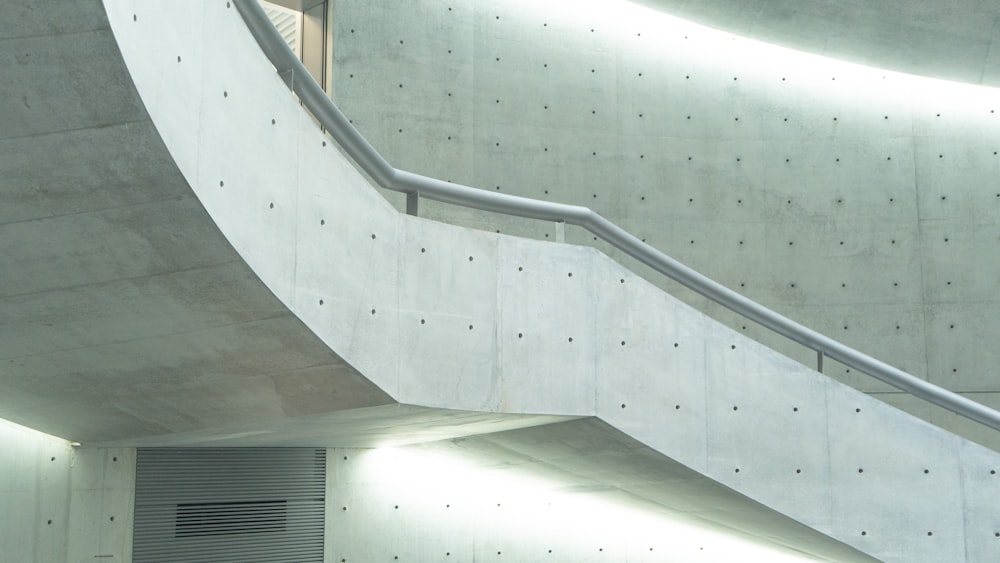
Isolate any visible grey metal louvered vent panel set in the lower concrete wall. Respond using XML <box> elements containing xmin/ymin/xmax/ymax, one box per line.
<box><xmin>132</xmin><ymin>448</ymin><xmax>326</xmax><ymax>563</ymax></box>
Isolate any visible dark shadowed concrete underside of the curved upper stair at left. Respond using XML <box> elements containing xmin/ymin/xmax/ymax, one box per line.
<box><xmin>0</xmin><ymin>0</ymin><xmax>391</xmax><ymax>443</ymax></box>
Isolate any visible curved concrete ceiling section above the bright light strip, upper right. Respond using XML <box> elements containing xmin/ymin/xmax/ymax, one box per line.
<box><xmin>633</xmin><ymin>0</ymin><xmax>1000</xmax><ymax>86</ymax></box>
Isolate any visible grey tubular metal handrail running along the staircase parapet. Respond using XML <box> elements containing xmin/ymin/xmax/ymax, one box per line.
<box><xmin>234</xmin><ymin>0</ymin><xmax>1000</xmax><ymax>430</ymax></box>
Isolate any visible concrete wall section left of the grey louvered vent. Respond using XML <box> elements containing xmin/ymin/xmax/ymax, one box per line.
<box><xmin>0</xmin><ymin>420</ymin><xmax>135</xmax><ymax>563</ymax></box>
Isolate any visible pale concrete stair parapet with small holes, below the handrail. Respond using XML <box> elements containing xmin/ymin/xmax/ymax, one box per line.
<box><xmin>108</xmin><ymin>1</ymin><xmax>1000</xmax><ymax>561</ymax></box>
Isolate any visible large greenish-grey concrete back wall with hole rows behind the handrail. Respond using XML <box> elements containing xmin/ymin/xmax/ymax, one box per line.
<box><xmin>333</xmin><ymin>0</ymin><xmax>1000</xmax><ymax>448</ymax></box>
